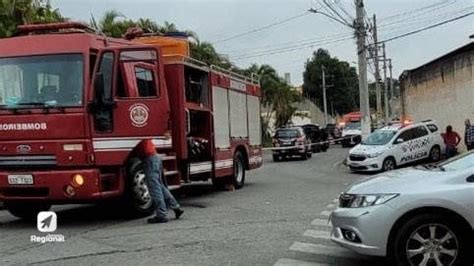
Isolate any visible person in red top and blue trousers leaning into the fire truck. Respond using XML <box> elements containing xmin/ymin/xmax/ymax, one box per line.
<box><xmin>138</xmin><ymin>139</ymin><xmax>184</xmax><ymax>224</ymax></box>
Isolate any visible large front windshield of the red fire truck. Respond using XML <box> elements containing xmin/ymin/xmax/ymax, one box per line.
<box><xmin>0</xmin><ymin>54</ymin><xmax>84</xmax><ymax>109</ymax></box>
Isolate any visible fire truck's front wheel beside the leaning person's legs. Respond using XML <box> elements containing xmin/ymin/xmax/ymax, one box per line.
<box><xmin>125</xmin><ymin>159</ymin><xmax>154</xmax><ymax>216</ymax></box>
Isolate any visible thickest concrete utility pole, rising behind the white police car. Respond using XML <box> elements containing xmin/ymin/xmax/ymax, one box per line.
<box><xmin>354</xmin><ymin>0</ymin><xmax>370</xmax><ymax>139</ymax></box>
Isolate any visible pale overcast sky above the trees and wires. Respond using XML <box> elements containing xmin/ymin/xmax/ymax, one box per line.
<box><xmin>52</xmin><ymin>0</ymin><xmax>474</xmax><ymax>85</ymax></box>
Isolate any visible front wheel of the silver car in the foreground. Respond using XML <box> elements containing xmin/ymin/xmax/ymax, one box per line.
<box><xmin>391</xmin><ymin>214</ymin><xmax>470</xmax><ymax>265</ymax></box>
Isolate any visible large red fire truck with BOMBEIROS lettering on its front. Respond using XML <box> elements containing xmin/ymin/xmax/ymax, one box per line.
<box><xmin>0</xmin><ymin>23</ymin><xmax>262</xmax><ymax>218</ymax></box>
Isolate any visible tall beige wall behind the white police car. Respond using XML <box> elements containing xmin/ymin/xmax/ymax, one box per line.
<box><xmin>401</xmin><ymin>47</ymin><xmax>474</xmax><ymax>150</ymax></box>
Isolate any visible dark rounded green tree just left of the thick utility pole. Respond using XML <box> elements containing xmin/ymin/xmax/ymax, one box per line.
<box><xmin>303</xmin><ymin>49</ymin><xmax>359</xmax><ymax>114</ymax></box>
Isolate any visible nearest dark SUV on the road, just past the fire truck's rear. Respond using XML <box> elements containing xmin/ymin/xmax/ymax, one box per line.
<box><xmin>273</xmin><ymin>127</ymin><xmax>311</xmax><ymax>162</ymax></box>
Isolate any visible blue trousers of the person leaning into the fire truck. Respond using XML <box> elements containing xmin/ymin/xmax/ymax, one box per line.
<box><xmin>143</xmin><ymin>154</ymin><xmax>180</xmax><ymax>218</ymax></box>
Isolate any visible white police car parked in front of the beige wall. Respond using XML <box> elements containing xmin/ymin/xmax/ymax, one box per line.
<box><xmin>346</xmin><ymin>120</ymin><xmax>444</xmax><ymax>171</ymax></box>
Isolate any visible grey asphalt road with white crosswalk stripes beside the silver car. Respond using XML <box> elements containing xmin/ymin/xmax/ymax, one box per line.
<box><xmin>0</xmin><ymin>147</ymin><xmax>384</xmax><ymax>265</ymax></box>
